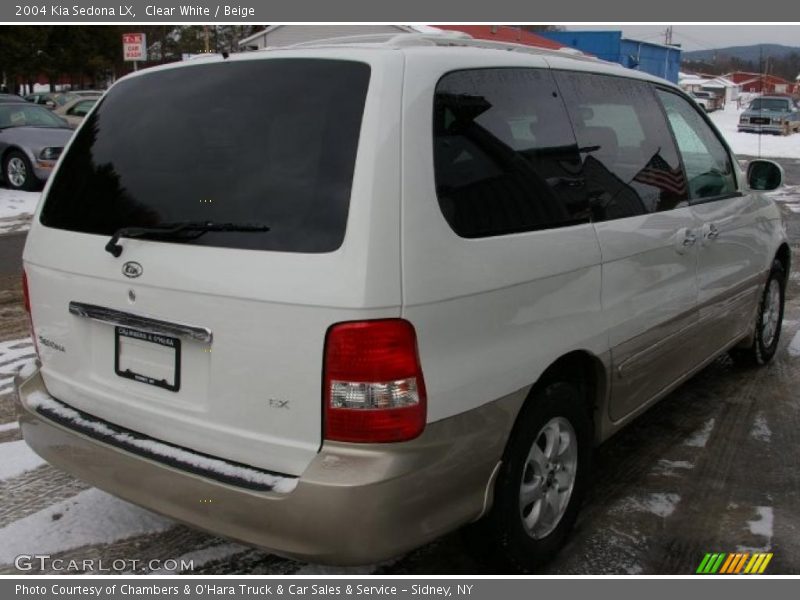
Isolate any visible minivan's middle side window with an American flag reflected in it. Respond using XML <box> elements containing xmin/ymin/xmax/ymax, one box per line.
<box><xmin>555</xmin><ymin>71</ymin><xmax>688</xmax><ymax>216</ymax></box>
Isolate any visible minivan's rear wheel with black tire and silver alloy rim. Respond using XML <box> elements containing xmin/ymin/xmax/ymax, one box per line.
<box><xmin>471</xmin><ymin>381</ymin><xmax>592</xmax><ymax>573</ymax></box>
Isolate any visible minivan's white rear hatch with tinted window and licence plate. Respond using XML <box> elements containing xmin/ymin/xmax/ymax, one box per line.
<box><xmin>24</xmin><ymin>52</ymin><xmax>401</xmax><ymax>475</ymax></box>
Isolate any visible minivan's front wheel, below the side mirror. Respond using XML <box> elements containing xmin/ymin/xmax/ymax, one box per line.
<box><xmin>729</xmin><ymin>260</ymin><xmax>786</xmax><ymax>366</ymax></box>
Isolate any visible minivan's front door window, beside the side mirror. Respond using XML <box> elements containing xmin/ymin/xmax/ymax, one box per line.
<box><xmin>657</xmin><ymin>90</ymin><xmax>736</xmax><ymax>200</ymax></box>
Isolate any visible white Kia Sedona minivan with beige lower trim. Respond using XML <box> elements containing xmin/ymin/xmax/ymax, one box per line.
<box><xmin>17</xmin><ymin>34</ymin><xmax>790</xmax><ymax>571</ymax></box>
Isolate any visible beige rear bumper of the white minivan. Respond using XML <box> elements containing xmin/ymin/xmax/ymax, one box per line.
<box><xmin>17</xmin><ymin>364</ymin><xmax>527</xmax><ymax>565</ymax></box>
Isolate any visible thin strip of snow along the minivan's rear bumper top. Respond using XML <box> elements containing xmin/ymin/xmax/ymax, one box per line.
<box><xmin>28</xmin><ymin>392</ymin><xmax>298</xmax><ymax>494</ymax></box>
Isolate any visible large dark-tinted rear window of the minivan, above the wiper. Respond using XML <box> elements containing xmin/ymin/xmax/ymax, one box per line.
<box><xmin>41</xmin><ymin>59</ymin><xmax>370</xmax><ymax>252</ymax></box>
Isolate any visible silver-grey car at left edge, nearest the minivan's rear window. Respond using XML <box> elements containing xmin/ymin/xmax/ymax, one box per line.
<box><xmin>0</xmin><ymin>101</ymin><xmax>72</xmax><ymax>190</ymax></box>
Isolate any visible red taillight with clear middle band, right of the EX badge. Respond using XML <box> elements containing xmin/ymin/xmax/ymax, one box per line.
<box><xmin>323</xmin><ymin>319</ymin><xmax>426</xmax><ymax>442</ymax></box>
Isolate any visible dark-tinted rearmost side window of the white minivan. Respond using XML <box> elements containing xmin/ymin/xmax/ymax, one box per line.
<box><xmin>433</xmin><ymin>68</ymin><xmax>592</xmax><ymax>238</ymax></box>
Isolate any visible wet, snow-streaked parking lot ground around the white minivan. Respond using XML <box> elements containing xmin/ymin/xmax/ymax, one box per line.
<box><xmin>0</xmin><ymin>159</ymin><xmax>800</xmax><ymax>575</ymax></box>
